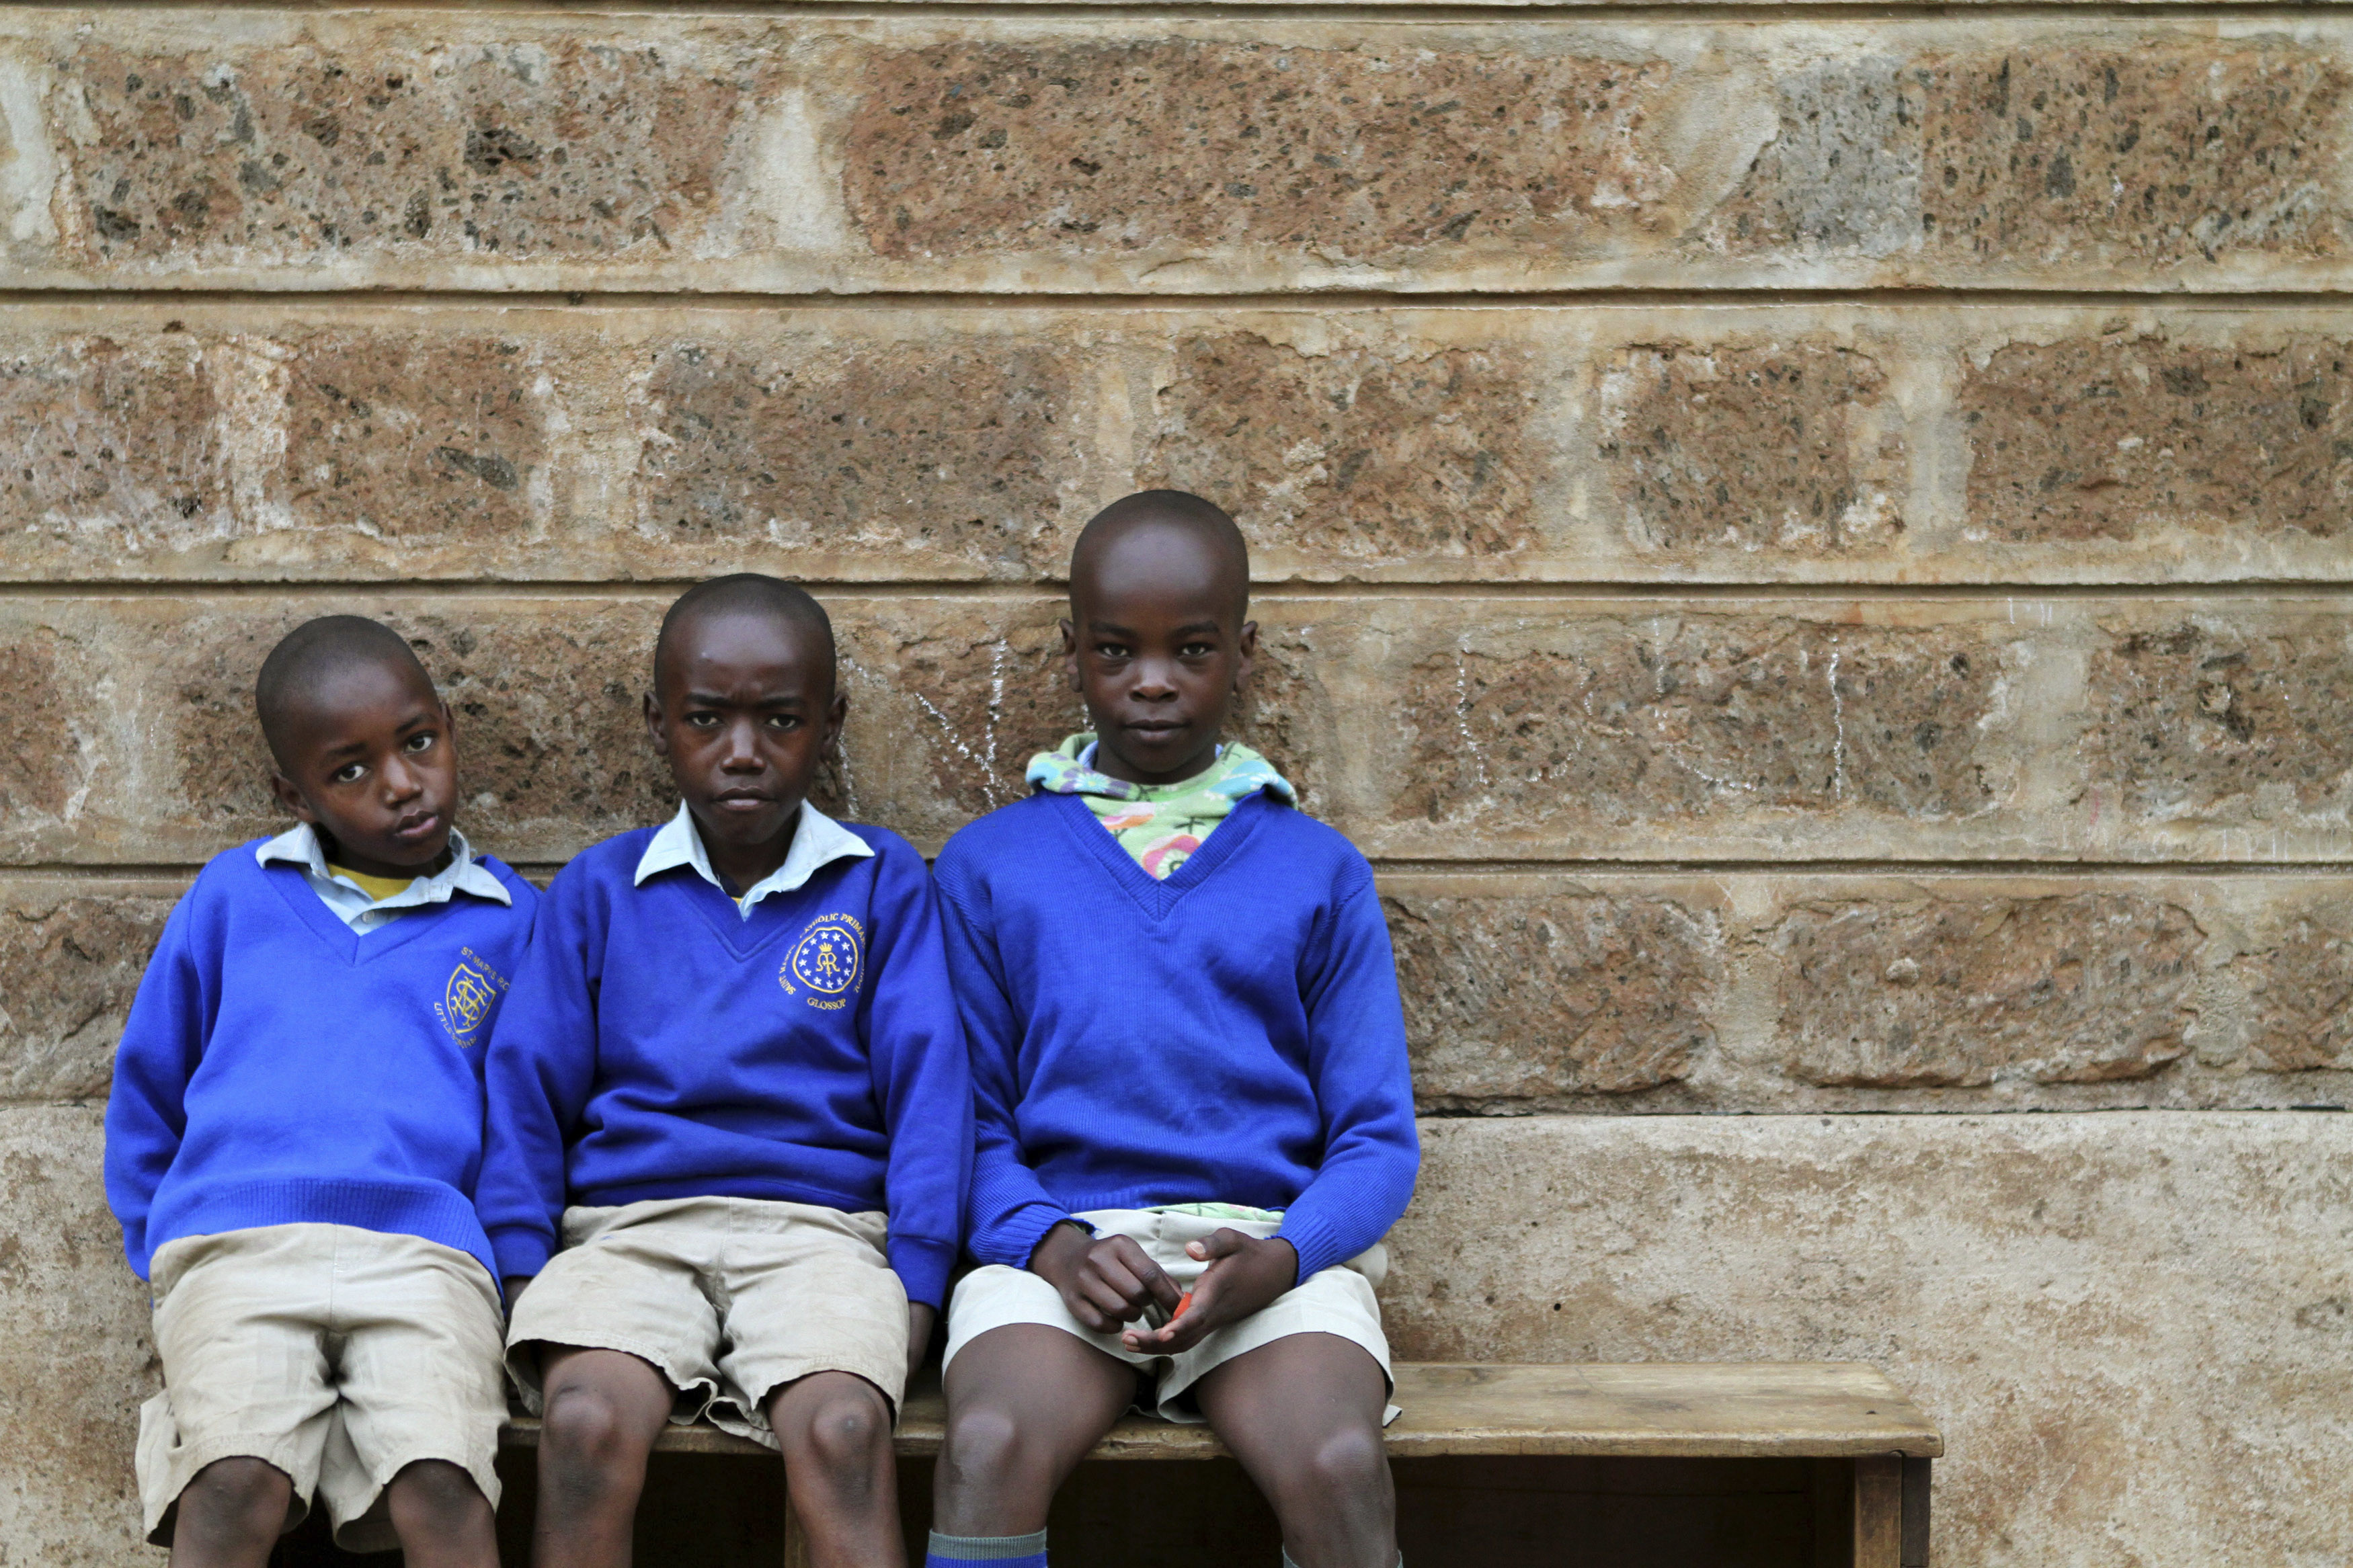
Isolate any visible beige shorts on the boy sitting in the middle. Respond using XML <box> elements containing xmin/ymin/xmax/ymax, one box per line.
<box><xmin>506</xmin><ymin>1196</ymin><xmax>908</xmax><ymax>1448</ymax></box>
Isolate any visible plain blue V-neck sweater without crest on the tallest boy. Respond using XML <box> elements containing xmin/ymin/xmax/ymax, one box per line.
<box><xmin>936</xmin><ymin>794</ymin><xmax>1421</xmax><ymax>1279</ymax></box>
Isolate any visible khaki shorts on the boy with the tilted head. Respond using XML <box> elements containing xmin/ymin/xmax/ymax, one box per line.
<box><xmin>139</xmin><ymin>1225</ymin><xmax>506</xmax><ymax>1552</ymax></box>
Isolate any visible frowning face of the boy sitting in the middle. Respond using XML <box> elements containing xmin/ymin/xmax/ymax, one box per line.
<box><xmin>645</xmin><ymin>611</ymin><xmax>850</xmax><ymax>854</ymax></box>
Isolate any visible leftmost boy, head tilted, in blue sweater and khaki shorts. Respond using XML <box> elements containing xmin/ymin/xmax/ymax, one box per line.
<box><xmin>106</xmin><ymin>616</ymin><xmax>536</xmax><ymax>1568</ymax></box>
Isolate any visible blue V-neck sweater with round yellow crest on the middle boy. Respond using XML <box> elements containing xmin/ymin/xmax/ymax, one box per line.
<box><xmin>480</xmin><ymin>823</ymin><xmax>972</xmax><ymax>1307</ymax></box>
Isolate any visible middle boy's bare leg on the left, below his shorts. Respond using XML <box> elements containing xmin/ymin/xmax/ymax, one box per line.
<box><xmin>532</xmin><ymin>1347</ymin><xmax>671</xmax><ymax>1568</ymax></box>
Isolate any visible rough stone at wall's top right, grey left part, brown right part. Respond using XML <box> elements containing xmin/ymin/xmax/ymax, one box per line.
<box><xmin>1708</xmin><ymin>35</ymin><xmax>2353</xmax><ymax>275</ymax></box>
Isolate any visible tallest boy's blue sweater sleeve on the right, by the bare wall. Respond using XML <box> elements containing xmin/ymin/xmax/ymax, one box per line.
<box><xmin>1275</xmin><ymin>872</ymin><xmax>1421</xmax><ymax>1279</ymax></box>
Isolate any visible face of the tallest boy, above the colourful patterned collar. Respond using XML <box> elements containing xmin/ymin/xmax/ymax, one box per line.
<box><xmin>1062</xmin><ymin>526</ymin><xmax>1259</xmax><ymax>785</ymax></box>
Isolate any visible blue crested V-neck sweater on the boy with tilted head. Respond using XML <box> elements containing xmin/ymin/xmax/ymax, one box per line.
<box><xmin>106</xmin><ymin>839</ymin><xmax>539</xmax><ymax>1279</ymax></box>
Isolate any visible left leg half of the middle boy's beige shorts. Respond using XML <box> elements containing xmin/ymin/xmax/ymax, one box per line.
<box><xmin>506</xmin><ymin>1199</ymin><xmax>725</xmax><ymax>1422</ymax></box>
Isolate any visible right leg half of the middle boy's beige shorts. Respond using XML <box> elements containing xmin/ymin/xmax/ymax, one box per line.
<box><xmin>711</xmin><ymin>1199</ymin><xmax>908</xmax><ymax>1439</ymax></box>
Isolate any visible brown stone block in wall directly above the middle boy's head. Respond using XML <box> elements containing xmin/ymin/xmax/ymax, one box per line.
<box><xmin>638</xmin><ymin>334</ymin><xmax>1109</xmax><ymax>578</ymax></box>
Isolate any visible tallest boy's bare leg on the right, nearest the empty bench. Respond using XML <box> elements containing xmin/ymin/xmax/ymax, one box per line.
<box><xmin>1193</xmin><ymin>1333</ymin><xmax>1398</xmax><ymax>1568</ymax></box>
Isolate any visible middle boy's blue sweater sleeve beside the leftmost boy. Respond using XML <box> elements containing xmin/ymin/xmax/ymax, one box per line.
<box><xmin>473</xmin><ymin>874</ymin><xmax>602</xmax><ymax>1279</ymax></box>
